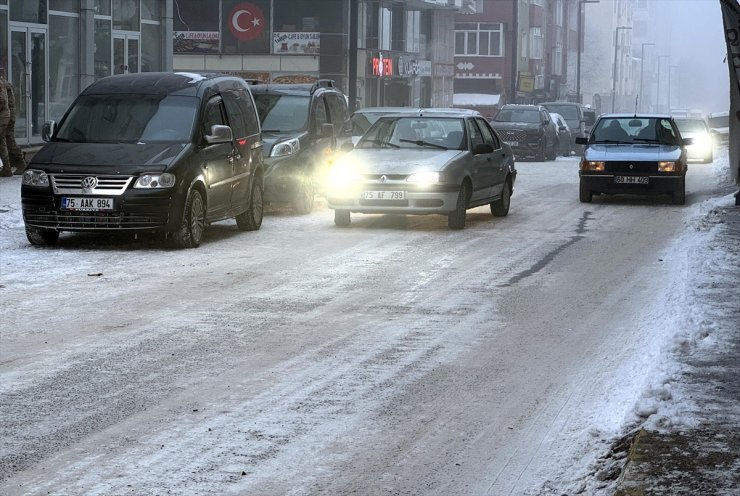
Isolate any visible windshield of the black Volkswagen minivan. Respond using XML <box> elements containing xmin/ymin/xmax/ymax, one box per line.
<box><xmin>54</xmin><ymin>94</ymin><xmax>198</xmax><ymax>143</ymax></box>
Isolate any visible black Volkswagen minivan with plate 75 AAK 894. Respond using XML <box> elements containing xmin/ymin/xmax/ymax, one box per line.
<box><xmin>21</xmin><ymin>72</ymin><xmax>264</xmax><ymax>248</ymax></box>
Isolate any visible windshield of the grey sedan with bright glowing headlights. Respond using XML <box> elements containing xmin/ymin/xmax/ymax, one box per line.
<box><xmin>357</xmin><ymin>117</ymin><xmax>464</xmax><ymax>150</ymax></box>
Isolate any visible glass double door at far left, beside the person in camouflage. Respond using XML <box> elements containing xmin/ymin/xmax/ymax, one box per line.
<box><xmin>8</xmin><ymin>25</ymin><xmax>49</xmax><ymax>145</ymax></box>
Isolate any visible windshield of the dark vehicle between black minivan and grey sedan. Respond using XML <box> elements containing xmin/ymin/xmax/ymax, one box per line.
<box><xmin>253</xmin><ymin>93</ymin><xmax>311</xmax><ymax>133</ymax></box>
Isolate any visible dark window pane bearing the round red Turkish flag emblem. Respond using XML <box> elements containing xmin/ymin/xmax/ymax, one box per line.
<box><xmin>221</xmin><ymin>0</ymin><xmax>271</xmax><ymax>54</ymax></box>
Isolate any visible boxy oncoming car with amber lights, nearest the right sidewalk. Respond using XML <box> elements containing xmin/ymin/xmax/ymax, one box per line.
<box><xmin>577</xmin><ymin>114</ymin><xmax>692</xmax><ymax>205</ymax></box>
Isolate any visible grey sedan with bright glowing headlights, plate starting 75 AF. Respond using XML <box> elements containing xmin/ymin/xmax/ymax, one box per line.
<box><xmin>326</xmin><ymin>109</ymin><xmax>516</xmax><ymax>229</ymax></box>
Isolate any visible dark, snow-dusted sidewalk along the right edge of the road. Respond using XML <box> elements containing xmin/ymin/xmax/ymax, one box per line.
<box><xmin>615</xmin><ymin>193</ymin><xmax>740</xmax><ymax>496</ymax></box>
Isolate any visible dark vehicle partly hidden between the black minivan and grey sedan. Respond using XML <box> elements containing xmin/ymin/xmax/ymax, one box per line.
<box><xmin>250</xmin><ymin>79</ymin><xmax>351</xmax><ymax>214</ymax></box>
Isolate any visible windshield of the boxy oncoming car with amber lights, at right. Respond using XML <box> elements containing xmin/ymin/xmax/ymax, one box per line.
<box><xmin>589</xmin><ymin>117</ymin><xmax>680</xmax><ymax>145</ymax></box>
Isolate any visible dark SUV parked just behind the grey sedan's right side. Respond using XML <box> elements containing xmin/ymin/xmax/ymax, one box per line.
<box><xmin>491</xmin><ymin>104</ymin><xmax>559</xmax><ymax>162</ymax></box>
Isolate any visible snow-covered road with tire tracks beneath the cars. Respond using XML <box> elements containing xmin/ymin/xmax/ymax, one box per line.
<box><xmin>0</xmin><ymin>157</ymin><xmax>726</xmax><ymax>495</ymax></box>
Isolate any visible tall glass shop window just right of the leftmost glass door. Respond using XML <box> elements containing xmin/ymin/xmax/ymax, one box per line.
<box><xmin>49</xmin><ymin>15</ymin><xmax>80</xmax><ymax>121</ymax></box>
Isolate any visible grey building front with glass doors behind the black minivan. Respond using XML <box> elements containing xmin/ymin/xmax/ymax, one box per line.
<box><xmin>0</xmin><ymin>0</ymin><xmax>172</xmax><ymax>145</ymax></box>
